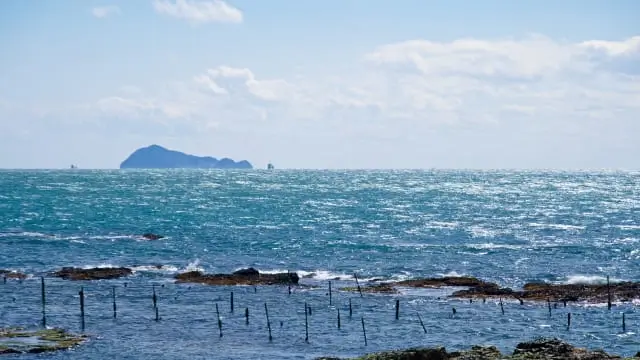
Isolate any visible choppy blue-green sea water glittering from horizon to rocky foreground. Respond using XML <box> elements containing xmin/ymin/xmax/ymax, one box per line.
<box><xmin>0</xmin><ymin>170</ymin><xmax>640</xmax><ymax>360</ymax></box>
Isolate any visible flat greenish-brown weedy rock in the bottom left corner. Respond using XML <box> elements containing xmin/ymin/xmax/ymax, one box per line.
<box><xmin>0</xmin><ymin>328</ymin><xmax>86</xmax><ymax>355</ymax></box>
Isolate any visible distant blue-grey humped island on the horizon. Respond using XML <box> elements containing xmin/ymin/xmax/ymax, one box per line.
<box><xmin>120</xmin><ymin>145</ymin><xmax>253</xmax><ymax>169</ymax></box>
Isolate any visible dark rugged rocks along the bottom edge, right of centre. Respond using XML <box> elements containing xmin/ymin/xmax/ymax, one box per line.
<box><xmin>316</xmin><ymin>339</ymin><xmax>640</xmax><ymax>360</ymax></box>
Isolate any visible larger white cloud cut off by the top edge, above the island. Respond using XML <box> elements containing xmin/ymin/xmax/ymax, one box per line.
<box><xmin>153</xmin><ymin>0</ymin><xmax>243</xmax><ymax>23</ymax></box>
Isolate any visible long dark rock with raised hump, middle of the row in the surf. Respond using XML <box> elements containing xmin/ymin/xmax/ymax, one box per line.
<box><xmin>175</xmin><ymin>268</ymin><xmax>300</xmax><ymax>285</ymax></box>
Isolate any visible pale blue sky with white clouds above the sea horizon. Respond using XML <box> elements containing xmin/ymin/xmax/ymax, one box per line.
<box><xmin>0</xmin><ymin>0</ymin><xmax>640</xmax><ymax>169</ymax></box>
